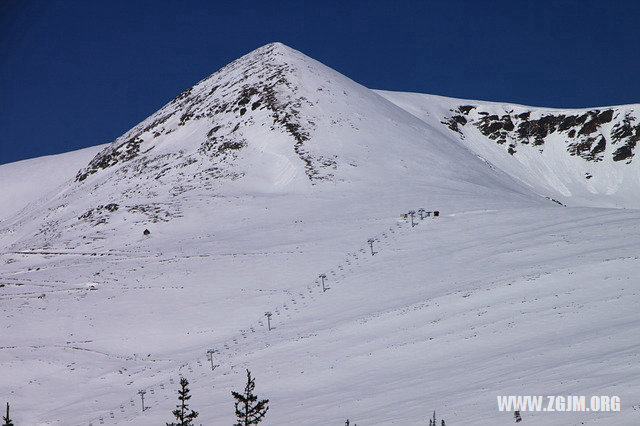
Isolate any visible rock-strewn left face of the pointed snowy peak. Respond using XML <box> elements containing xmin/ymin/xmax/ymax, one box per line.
<box><xmin>76</xmin><ymin>43</ymin><xmax>335</xmax><ymax>186</ymax></box>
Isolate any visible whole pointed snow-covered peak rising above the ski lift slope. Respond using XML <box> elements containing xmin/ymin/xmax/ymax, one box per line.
<box><xmin>0</xmin><ymin>43</ymin><xmax>537</xmax><ymax>250</ymax></box>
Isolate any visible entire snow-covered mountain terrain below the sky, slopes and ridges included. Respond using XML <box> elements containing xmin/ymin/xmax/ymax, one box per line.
<box><xmin>0</xmin><ymin>43</ymin><xmax>640</xmax><ymax>425</ymax></box>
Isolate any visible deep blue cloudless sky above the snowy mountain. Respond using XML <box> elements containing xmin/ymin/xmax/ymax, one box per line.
<box><xmin>0</xmin><ymin>0</ymin><xmax>640</xmax><ymax>164</ymax></box>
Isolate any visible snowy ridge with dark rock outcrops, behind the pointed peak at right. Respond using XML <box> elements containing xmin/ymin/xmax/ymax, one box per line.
<box><xmin>379</xmin><ymin>91</ymin><xmax>640</xmax><ymax>207</ymax></box>
